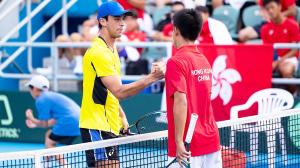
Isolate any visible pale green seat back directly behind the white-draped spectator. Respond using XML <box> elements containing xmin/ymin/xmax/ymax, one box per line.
<box><xmin>212</xmin><ymin>5</ymin><xmax>239</xmax><ymax>37</ymax></box>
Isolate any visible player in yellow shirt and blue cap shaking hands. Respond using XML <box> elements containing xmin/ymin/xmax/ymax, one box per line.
<box><xmin>79</xmin><ymin>1</ymin><xmax>165</xmax><ymax>167</ymax></box>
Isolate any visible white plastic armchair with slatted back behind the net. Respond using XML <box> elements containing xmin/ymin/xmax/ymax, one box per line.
<box><xmin>230</xmin><ymin>88</ymin><xmax>294</xmax><ymax>167</ymax></box>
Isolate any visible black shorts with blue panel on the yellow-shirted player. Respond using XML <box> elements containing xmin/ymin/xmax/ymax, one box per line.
<box><xmin>80</xmin><ymin>128</ymin><xmax>119</xmax><ymax>167</ymax></box>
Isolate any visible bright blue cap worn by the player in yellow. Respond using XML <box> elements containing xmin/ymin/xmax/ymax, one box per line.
<box><xmin>97</xmin><ymin>1</ymin><xmax>130</xmax><ymax>20</ymax></box>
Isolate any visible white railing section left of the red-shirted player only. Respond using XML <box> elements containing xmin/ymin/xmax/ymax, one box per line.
<box><xmin>0</xmin><ymin>42</ymin><xmax>172</xmax><ymax>91</ymax></box>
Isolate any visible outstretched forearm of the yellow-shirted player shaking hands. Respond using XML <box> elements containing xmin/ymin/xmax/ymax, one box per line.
<box><xmin>115</xmin><ymin>75</ymin><xmax>157</xmax><ymax>100</ymax></box>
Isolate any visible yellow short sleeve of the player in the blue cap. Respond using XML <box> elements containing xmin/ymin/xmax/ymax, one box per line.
<box><xmin>91</xmin><ymin>51</ymin><xmax>118</xmax><ymax>77</ymax></box>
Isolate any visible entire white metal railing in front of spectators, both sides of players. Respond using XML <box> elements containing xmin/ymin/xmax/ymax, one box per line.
<box><xmin>0</xmin><ymin>42</ymin><xmax>300</xmax><ymax>90</ymax></box>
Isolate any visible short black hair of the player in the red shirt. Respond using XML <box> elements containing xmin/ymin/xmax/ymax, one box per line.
<box><xmin>173</xmin><ymin>9</ymin><xmax>203</xmax><ymax>41</ymax></box>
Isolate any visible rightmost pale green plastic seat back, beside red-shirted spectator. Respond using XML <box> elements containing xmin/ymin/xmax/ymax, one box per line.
<box><xmin>242</xmin><ymin>5</ymin><xmax>264</xmax><ymax>27</ymax></box>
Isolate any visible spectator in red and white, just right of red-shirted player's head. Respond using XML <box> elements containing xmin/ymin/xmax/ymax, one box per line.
<box><xmin>196</xmin><ymin>6</ymin><xmax>233</xmax><ymax>45</ymax></box>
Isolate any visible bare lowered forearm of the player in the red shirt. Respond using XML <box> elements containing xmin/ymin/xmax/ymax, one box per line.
<box><xmin>173</xmin><ymin>93</ymin><xmax>187</xmax><ymax>144</ymax></box>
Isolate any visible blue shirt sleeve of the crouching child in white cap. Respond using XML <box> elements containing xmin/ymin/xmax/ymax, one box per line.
<box><xmin>35</xmin><ymin>99</ymin><xmax>52</xmax><ymax>120</ymax></box>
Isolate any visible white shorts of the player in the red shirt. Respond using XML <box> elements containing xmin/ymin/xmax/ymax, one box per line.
<box><xmin>168</xmin><ymin>151</ymin><xmax>222</xmax><ymax>168</ymax></box>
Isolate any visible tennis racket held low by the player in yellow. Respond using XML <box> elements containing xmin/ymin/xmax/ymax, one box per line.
<box><xmin>121</xmin><ymin>111</ymin><xmax>168</xmax><ymax>135</ymax></box>
